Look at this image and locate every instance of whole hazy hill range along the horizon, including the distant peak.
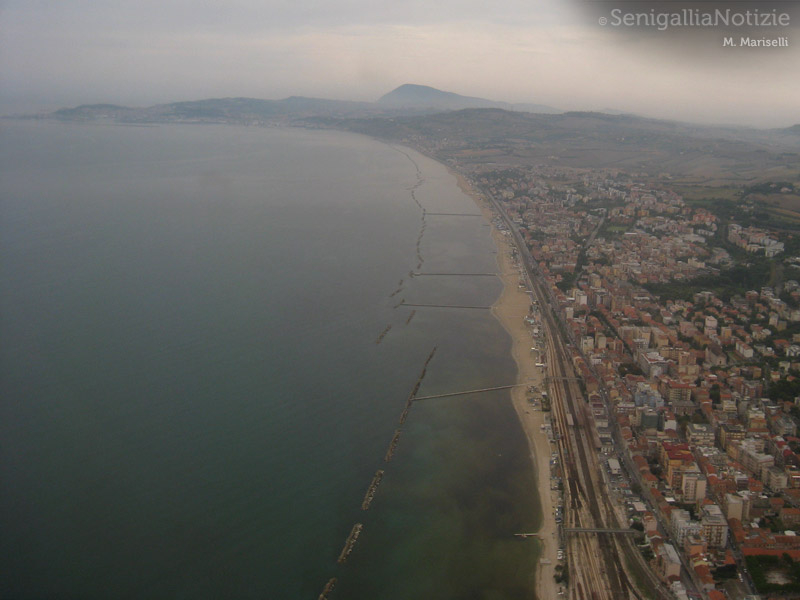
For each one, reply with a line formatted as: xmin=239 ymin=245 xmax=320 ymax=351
xmin=26 ymin=84 xmax=800 ymax=185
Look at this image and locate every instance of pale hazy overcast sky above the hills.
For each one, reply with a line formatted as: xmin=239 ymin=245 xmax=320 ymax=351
xmin=0 ymin=0 xmax=800 ymax=127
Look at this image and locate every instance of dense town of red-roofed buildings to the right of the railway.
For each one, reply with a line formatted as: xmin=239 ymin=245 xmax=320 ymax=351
xmin=468 ymin=166 xmax=800 ymax=599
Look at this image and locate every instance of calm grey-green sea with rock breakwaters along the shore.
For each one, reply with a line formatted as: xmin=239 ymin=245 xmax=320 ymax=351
xmin=0 ymin=120 xmax=542 ymax=600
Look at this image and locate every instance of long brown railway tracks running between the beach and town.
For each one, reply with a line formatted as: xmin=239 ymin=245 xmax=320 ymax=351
xmin=496 ymin=198 xmax=672 ymax=600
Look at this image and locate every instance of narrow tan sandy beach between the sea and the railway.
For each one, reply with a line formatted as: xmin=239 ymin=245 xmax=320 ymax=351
xmin=456 ymin=174 xmax=558 ymax=600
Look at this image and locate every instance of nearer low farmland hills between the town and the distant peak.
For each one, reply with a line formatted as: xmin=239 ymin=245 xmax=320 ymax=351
xmin=337 ymin=108 xmax=800 ymax=184
